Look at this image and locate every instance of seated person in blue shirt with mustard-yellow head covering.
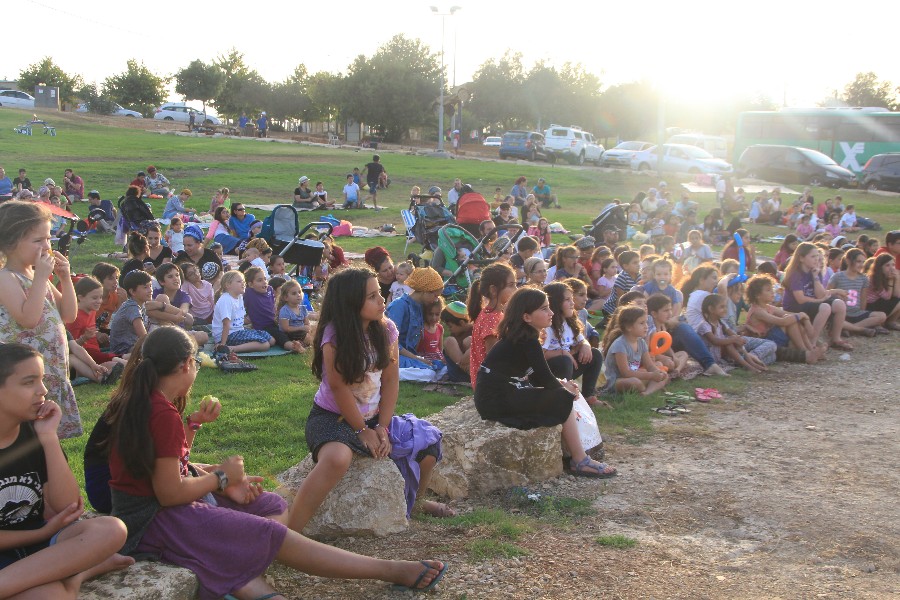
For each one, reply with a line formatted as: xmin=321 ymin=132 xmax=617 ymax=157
xmin=386 ymin=267 xmax=444 ymax=369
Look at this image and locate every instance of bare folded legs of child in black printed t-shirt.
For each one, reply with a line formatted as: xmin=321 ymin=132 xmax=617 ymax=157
xmin=0 ymin=517 xmax=134 ymax=600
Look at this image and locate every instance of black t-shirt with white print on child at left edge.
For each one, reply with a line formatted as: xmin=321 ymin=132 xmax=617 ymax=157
xmin=0 ymin=422 xmax=47 ymax=531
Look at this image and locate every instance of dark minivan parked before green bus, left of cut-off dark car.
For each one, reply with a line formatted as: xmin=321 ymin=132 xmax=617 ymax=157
xmin=737 ymin=144 xmax=857 ymax=188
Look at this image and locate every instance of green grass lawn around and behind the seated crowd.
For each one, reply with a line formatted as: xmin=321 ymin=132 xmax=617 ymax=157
xmin=0 ymin=109 xmax=900 ymax=506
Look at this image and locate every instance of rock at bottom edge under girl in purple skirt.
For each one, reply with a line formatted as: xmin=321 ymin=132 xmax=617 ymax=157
xmin=78 ymin=561 xmax=198 ymax=600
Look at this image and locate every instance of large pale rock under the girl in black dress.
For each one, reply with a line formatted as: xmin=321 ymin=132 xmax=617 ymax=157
xmin=428 ymin=397 xmax=562 ymax=498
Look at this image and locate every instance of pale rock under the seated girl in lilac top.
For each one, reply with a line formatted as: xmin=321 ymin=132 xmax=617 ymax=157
xmin=275 ymin=454 xmax=408 ymax=538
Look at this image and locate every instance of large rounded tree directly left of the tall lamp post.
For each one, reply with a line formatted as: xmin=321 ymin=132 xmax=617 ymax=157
xmin=341 ymin=35 xmax=440 ymax=141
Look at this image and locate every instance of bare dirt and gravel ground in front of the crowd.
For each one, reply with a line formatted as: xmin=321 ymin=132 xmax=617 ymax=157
xmin=272 ymin=335 xmax=900 ymax=600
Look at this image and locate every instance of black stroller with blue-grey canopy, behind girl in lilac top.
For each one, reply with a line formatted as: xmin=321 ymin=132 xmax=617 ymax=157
xmin=259 ymin=204 xmax=334 ymax=287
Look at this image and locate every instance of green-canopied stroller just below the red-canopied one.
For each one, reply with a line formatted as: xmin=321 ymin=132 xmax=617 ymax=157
xmin=438 ymin=224 xmax=522 ymax=300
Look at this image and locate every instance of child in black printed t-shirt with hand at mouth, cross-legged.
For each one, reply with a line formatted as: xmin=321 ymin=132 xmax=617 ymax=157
xmin=0 ymin=344 xmax=134 ymax=598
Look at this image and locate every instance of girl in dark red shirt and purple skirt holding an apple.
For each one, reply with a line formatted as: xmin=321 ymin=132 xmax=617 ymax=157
xmin=106 ymin=327 xmax=446 ymax=600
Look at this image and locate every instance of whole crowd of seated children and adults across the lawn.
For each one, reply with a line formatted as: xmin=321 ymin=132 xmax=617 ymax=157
xmin=0 ymin=157 xmax=900 ymax=595
